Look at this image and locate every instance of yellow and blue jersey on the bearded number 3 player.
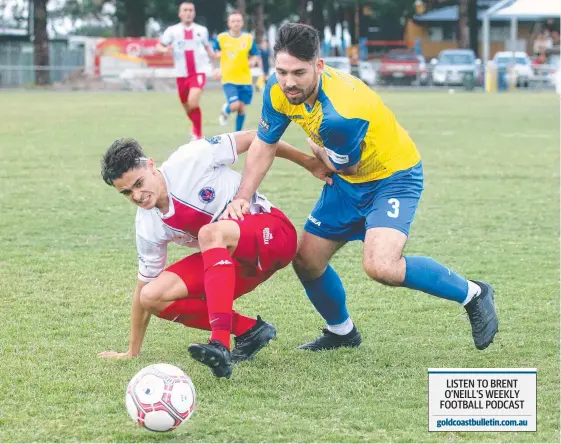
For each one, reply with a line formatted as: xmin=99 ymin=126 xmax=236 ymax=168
xmin=258 ymin=66 xmax=421 ymax=183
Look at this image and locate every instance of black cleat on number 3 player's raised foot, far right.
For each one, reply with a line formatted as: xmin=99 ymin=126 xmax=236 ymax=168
xmin=464 ymin=281 xmax=499 ymax=350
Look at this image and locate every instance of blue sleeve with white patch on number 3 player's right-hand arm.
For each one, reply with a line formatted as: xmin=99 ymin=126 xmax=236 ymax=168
xmin=319 ymin=116 xmax=369 ymax=169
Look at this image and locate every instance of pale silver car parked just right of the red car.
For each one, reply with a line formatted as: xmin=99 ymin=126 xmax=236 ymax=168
xmin=431 ymin=49 xmax=481 ymax=86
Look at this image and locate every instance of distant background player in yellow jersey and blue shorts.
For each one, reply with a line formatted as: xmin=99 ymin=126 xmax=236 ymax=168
xmin=214 ymin=11 xmax=259 ymax=131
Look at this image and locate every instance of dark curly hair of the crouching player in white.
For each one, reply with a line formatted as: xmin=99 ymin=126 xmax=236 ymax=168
xmin=101 ymin=139 xmax=146 ymax=186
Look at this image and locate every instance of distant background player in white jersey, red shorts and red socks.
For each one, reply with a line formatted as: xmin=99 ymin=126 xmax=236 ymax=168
xmin=156 ymin=2 xmax=215 ymax=140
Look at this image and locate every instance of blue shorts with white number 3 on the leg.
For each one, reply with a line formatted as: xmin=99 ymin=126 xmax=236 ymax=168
xmin=304 ymin=162 xmax=423 ymax=241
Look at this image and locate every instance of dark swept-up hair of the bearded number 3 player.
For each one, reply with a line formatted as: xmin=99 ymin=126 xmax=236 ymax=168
xmin=273 ymin=23 xmax=320 ymax=62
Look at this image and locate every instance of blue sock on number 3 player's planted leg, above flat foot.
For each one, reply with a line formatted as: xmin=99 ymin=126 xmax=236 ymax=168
xmin=300 ymin=265 xmax=349 ymax=325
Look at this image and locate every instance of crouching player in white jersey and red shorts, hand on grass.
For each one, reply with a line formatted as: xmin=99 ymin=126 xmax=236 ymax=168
xmin=100 ymin=131 xmax=331 ymax=377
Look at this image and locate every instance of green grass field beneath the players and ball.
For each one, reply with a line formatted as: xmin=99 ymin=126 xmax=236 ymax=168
xmin=0 ymin=91 xmax=560 ymax=442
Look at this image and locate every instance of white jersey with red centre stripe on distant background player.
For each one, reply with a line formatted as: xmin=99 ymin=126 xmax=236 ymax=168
xmin=160 ymin=23 xmax=210 ymax=77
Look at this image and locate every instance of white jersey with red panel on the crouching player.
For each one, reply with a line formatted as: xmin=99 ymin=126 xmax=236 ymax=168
xmin=136 ymin=134 xmax=272 ymax=282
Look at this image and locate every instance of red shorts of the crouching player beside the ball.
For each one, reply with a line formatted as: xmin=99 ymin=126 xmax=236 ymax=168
xmin=166 ymin=208 xmax=298 ymax=298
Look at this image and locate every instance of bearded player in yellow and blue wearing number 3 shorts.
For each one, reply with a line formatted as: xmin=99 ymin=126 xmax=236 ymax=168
xmin=222 ymin=23 xmax=498 ymax=351
